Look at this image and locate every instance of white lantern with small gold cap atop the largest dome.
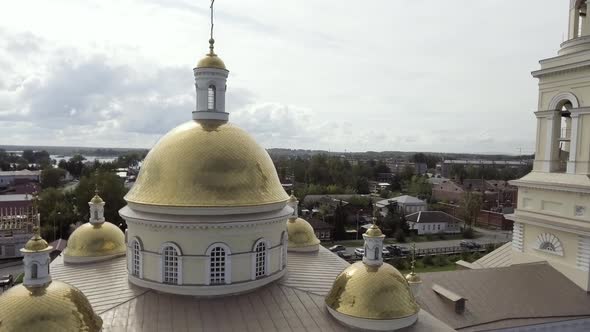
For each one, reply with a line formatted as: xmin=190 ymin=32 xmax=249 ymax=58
xmin=193 ymin=37 xmax=229 ymax=121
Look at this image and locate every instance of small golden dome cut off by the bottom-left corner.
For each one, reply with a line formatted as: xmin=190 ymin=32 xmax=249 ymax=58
xmin=0 ymin=281 xmax=102 ymax=332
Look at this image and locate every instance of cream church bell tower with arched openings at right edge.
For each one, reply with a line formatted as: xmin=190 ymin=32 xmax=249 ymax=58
xmin=511 ymin=0 xmax=590 ymax=291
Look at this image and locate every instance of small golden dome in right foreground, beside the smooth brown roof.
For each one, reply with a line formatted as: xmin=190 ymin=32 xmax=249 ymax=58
xmin=326 ymin=262 xmax=420 ymax=320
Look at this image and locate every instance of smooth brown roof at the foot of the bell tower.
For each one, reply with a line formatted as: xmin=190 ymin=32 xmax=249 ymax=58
xmin=418 ymin=263 xmax=590 ymax=331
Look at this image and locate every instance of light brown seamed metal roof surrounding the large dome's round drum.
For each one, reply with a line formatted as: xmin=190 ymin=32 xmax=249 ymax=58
xmin=51 ymin=247 xmax=453 ymax=331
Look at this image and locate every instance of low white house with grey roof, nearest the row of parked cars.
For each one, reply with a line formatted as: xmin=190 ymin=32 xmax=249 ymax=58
xmin=406 ymin=211 xmax=463 ymax=235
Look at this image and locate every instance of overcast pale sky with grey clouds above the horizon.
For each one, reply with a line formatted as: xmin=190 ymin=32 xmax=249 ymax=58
xmin=0 ymin=0 xmax=569 ymax=153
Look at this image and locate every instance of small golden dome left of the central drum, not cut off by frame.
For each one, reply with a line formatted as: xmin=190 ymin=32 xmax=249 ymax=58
xmin=64 ymin=222 xmax=126 ymax=260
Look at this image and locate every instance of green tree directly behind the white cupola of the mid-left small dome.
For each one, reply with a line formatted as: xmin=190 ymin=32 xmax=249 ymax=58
xmin=74 ymin=171 xmax=127 ymax=225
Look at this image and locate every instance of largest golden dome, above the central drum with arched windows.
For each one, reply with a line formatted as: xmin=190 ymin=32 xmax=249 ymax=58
xmin=125 ymin=120 xmax=289 ymax=207
